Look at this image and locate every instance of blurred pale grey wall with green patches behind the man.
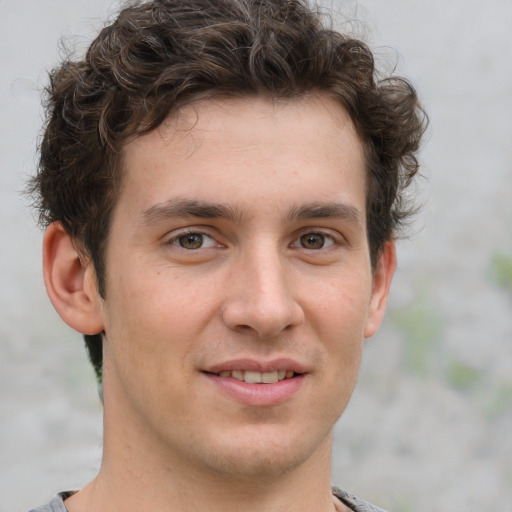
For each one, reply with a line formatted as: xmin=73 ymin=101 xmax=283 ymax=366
xmin=0 ymin=0 xmax=512 ymax=512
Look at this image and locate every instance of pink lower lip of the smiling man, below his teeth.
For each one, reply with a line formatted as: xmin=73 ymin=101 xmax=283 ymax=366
xmin=204 ymin=373 xmax=306 ymax=407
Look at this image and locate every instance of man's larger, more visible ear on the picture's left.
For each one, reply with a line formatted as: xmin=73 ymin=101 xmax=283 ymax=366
xmin=43 ymin=222 xmax=103 ymax=334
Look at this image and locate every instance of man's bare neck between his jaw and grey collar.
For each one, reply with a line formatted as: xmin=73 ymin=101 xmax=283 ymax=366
xmin=66 ymin=424 xmax=335 ymax=512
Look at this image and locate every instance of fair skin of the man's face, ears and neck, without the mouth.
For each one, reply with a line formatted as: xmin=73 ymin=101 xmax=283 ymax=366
xmin=44 ymin=95 xmax=395 ymax=512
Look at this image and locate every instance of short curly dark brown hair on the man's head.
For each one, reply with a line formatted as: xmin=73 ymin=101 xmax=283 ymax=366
xmin=29 ymin=0 xmax=427 ymax=380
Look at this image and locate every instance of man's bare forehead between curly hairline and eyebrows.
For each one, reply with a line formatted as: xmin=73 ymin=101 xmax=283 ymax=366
xmin=118 ymin=94 xmax=365 ymax=221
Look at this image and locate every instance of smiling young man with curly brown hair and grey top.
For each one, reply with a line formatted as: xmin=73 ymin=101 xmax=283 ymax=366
xmin=32 ymin=0 xmax=424 ymax=512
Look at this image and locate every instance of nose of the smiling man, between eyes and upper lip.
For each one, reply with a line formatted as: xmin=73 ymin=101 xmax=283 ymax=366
xmin=222 ymin=248 xmax=304 ymax=339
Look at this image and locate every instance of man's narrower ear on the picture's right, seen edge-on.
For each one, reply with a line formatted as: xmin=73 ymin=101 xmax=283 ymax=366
xmin=364 ymin=240 xmax=396 ymax=338
